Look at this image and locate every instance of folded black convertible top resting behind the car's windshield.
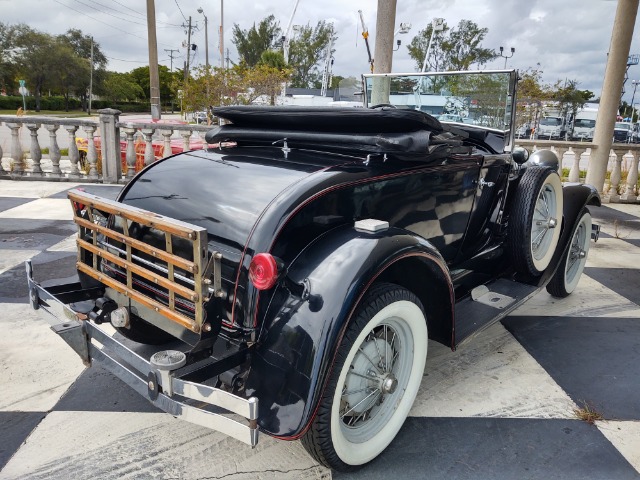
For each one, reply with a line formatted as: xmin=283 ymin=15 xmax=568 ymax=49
xmin=205 ymin=105 xmax=467 ymax=159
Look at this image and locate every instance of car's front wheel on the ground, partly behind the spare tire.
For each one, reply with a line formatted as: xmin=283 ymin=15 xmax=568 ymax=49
xmin=547 ymin=208 xmax=591 ymax=298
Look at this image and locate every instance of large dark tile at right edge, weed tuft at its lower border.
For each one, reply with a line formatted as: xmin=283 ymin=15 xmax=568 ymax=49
xmin=502 ymin=317 xmax=640 ymax=420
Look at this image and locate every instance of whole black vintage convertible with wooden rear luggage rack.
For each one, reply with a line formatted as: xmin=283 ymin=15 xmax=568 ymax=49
xmin=27 ymin=71 xmax=600 ymax=470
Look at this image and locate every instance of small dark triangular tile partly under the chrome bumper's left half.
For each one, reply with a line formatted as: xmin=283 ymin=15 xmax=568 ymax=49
xmin=53 ymin=360 xmax=161 ymax=412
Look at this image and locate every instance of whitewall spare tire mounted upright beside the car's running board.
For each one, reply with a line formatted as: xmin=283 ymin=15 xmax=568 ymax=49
xmin=507 ymin=166 xmax=563 ymax=275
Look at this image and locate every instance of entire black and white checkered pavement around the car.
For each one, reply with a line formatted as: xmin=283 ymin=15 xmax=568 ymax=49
xmin=0 ymin=180 xmax=640 ymax=480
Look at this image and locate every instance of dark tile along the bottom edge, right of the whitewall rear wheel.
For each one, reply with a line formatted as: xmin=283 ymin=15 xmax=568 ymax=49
xmin=333 ymin=417 xmax=640 ymax=480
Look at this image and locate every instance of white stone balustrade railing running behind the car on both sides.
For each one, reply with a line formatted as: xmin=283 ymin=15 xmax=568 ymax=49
xmin=0 ymin=115 xmax=640 ymax=203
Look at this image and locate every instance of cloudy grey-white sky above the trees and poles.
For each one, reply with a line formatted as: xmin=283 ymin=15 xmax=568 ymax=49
xmin=0 ymin=0 xmax=640 ymax=101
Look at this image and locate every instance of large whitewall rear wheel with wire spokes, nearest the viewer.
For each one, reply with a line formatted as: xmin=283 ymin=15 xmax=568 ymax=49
xmin=302 ymin=284 xmax=428 ymax=471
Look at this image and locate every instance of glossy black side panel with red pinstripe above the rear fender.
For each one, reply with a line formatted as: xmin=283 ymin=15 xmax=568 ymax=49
xmin=240 ymin=156 xmax=480 ymax=327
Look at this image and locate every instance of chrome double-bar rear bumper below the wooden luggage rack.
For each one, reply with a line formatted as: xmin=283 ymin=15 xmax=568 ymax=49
xmin=26 ymin=261 xmax=258 ymax=447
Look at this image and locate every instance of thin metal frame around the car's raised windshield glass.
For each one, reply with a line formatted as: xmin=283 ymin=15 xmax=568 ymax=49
xmin=362 ymin=70 xmax=518 ymax=152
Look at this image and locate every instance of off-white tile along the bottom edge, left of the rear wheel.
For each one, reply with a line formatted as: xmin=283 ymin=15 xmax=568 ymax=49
xmin=0 ymin=412 xmax=330 ymax=480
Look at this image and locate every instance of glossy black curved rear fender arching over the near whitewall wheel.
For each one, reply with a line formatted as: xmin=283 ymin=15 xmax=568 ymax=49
xmin=242 ymin=226 xmax=454 ymax=439
